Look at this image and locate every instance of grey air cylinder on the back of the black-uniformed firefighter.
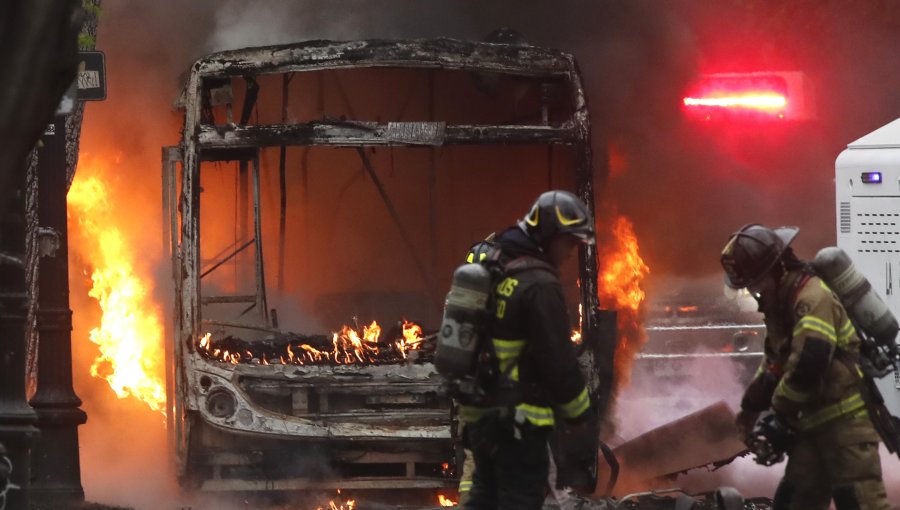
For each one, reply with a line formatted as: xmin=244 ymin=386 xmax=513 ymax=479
xmin=434 ymin=264 xmax=491 ymax=379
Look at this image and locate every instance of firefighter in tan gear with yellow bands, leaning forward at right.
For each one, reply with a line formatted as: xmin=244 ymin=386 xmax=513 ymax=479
xmin=721 ymin=225 xmax=889 ymax=510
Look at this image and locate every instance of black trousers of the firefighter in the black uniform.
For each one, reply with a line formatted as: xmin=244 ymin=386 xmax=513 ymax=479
xmin=462 ymin=418 xmax=549 ymax=510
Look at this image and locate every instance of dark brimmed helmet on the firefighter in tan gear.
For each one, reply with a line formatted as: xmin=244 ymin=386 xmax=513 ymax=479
xmin=721 ymin=224 xmax=800 ymax=289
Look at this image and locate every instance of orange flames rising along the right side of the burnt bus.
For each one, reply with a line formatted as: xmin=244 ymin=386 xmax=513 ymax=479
xmin=598 ymin=216 xmax=650 ymax=388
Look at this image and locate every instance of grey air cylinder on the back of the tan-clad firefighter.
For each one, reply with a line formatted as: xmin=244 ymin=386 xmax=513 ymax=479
xmin=813 ymin=246 xmax=900 ymax=375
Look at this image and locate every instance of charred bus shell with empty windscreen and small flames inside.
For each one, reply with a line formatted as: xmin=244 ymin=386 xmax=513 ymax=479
xmin=162 ymin=39 xmax=765 ymax=508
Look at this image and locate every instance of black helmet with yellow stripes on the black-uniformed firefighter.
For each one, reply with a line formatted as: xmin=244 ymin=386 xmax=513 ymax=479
xmin=519 ymin=190 xmax=594 ymax=248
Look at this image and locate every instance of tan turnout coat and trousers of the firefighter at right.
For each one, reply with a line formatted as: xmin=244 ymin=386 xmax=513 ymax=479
xmin=741 ymin=270 xmax=888 ymax=510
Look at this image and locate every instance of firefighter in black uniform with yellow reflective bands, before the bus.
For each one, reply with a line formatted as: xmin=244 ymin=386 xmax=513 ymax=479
xmin=459 ymin=191 xmax=597 ymax=510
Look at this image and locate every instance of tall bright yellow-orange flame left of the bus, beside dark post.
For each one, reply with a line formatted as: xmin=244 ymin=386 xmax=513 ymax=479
xmin=68 ymin=157 xmax=166 ymax=414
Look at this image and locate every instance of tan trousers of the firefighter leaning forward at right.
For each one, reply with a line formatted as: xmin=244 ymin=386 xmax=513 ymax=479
xmin=774 ymin=417 xmax=890 ymax=510
